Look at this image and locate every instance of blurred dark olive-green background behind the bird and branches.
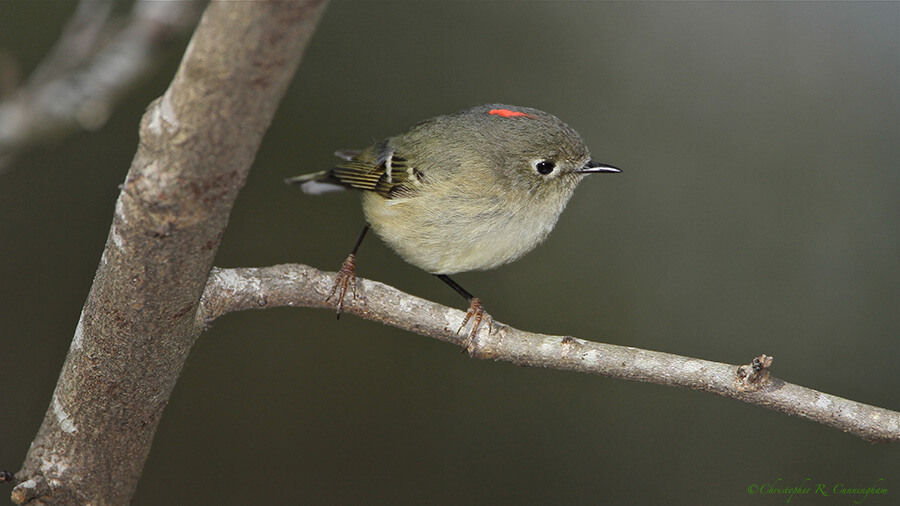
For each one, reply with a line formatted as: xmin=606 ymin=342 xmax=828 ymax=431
xmin=0 ymin=1 xmax=900 ymax=505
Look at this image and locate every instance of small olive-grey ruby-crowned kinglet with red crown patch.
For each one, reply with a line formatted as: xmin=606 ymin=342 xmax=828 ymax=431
xmin=285 ymin=104 xmax=620 ymax=338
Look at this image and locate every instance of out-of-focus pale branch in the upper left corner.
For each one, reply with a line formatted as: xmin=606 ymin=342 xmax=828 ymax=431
xmin=0 ymin=0 xmax=200 ymax=170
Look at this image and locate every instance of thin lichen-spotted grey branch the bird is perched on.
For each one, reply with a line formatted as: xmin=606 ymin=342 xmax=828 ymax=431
xmin=197 ymin=264 xmax=900 ymax=443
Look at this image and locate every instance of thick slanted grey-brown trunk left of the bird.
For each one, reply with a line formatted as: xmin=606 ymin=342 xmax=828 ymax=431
xmin=13 ymin=0 xmax=324 ymax=504
